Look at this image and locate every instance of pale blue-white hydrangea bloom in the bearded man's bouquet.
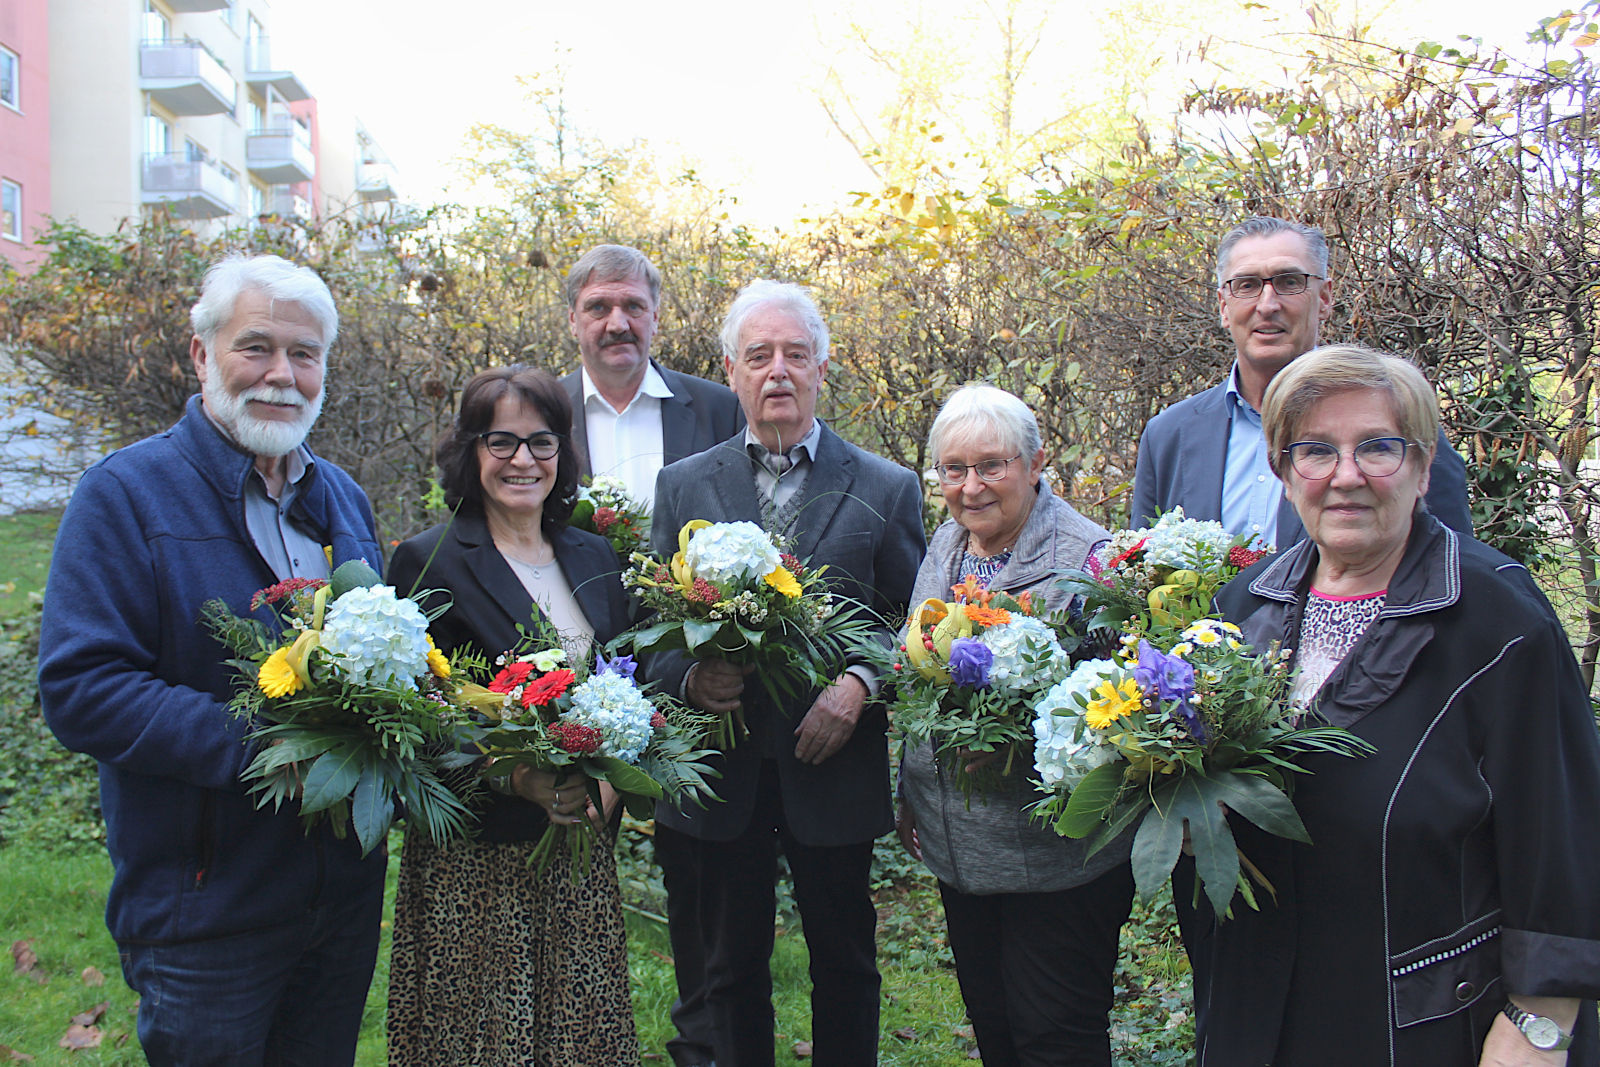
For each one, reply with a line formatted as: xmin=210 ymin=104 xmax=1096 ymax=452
xmin=322 ymin=585 xmax=429 ymax=689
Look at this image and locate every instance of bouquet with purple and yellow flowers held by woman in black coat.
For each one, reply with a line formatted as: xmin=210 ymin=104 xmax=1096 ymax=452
xmin=1034 ymin=619 xmax=1373 ymax=917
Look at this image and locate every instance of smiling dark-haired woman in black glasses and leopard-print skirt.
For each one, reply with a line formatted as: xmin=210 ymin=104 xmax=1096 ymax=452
xmin=389 ymin=365 xmax=638 ymax=1067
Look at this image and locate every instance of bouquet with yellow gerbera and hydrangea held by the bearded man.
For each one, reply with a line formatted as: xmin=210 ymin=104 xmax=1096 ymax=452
xmin=203 ymin=560 xmax=472 ymax=856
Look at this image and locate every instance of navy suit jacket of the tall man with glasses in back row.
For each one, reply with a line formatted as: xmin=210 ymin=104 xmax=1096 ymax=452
xmin=1128 ymin=382 xmax=1472 ymax=550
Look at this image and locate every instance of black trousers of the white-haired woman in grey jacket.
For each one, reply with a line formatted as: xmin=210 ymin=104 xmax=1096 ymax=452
xmin=939 ymin=864 xmax=1133 ymax=1067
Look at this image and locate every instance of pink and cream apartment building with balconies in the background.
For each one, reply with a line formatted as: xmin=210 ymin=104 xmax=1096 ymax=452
xmin=0 ymin=0 xmax=395 ymax=271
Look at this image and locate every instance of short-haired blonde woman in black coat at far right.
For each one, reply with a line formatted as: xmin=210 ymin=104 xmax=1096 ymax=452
xmin=1197 ymin=346 xmax=1600 ymax=1067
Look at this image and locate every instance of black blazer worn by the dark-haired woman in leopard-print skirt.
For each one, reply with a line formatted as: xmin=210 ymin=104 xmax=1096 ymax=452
xmin=387 ymin=509 xmax=632 ymax=841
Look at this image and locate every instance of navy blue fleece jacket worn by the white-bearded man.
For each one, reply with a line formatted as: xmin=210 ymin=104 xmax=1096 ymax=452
xmin=38 ymin=397 xmax=384 ymax=942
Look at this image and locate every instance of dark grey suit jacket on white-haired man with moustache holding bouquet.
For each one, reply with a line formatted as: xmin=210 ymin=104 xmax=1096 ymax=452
xmin=648 ymin=427 xmax=926 ymax=846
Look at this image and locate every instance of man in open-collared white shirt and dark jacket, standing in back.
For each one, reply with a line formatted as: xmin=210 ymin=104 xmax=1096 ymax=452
xmin=562 ymin=245 xmax=744 ymax=509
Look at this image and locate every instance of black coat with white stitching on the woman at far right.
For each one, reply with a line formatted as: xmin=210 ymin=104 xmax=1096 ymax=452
xmin=1186 ymin=515 xmax=1600 ymax=1067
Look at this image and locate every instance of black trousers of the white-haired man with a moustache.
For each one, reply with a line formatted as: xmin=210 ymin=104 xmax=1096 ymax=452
xmin=693 ymin=760 xmax=882 ymax=1067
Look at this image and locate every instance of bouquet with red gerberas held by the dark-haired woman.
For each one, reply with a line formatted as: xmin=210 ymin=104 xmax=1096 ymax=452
xmin=466 ymin=643 xmax=717 ymax=881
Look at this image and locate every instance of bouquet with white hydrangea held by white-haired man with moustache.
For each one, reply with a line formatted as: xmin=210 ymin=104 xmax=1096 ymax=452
xmin=614 ymin=518 xmax=872 ymax=749
